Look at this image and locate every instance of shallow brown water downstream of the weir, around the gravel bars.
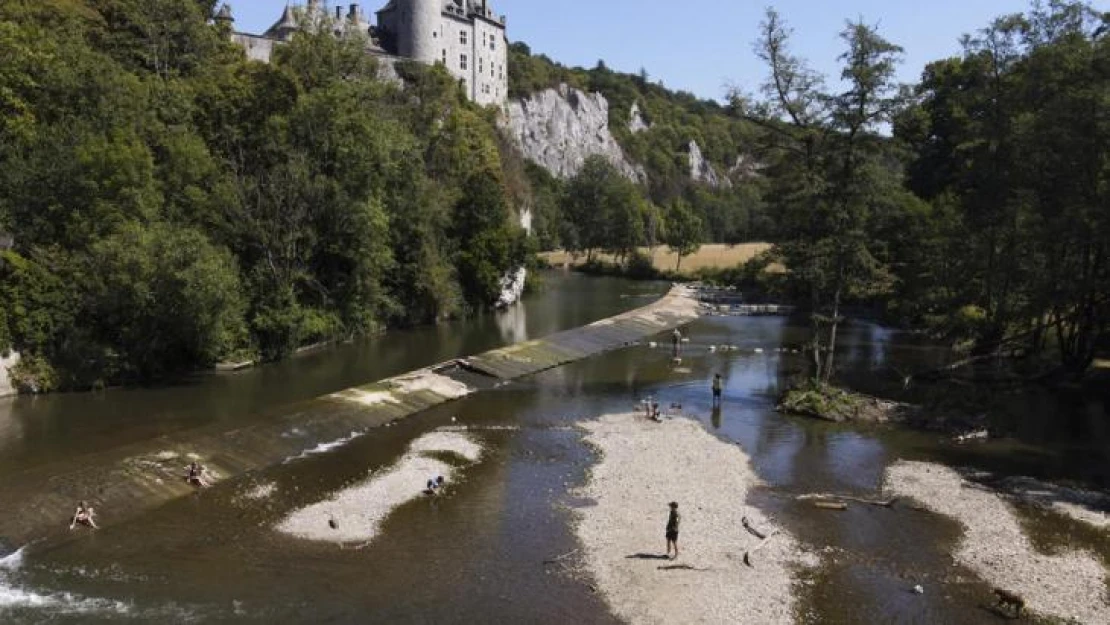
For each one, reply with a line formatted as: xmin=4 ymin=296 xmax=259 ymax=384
xmin=0 ymin=295 xmax=1110 ymax=624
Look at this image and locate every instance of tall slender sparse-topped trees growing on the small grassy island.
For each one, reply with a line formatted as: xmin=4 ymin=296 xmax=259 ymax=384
xmin=733 ymin=9 xmax=902 ymax=384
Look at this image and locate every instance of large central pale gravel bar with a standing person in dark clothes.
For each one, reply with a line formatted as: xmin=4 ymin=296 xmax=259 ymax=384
xmin=577 ymin=414 xmax=816 ymax=624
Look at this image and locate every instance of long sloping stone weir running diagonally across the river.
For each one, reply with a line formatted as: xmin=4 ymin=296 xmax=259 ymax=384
xmin=0 ymin=286 xmax=698 ymax=545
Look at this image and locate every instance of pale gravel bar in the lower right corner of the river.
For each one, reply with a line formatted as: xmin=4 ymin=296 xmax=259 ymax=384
xmin=886 ymin=462 xmax=1110 ymax=623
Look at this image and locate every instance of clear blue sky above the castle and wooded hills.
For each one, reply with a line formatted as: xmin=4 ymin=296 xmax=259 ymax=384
xmin=230 ymin=0 xmax=1047 ymax=99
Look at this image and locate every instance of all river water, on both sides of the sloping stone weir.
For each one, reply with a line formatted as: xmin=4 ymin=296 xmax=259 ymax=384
xmin=0 ymin=274 xmax=1110 ymax=624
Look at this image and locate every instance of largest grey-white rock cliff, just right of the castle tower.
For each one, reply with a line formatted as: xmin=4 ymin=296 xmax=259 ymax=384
xmin=506 ymin=84 xmax=646 ymax=181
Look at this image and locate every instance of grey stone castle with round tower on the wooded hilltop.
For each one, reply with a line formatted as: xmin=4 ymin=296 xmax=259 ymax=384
xmin=224 ymin=0 xmax=508 ymax=105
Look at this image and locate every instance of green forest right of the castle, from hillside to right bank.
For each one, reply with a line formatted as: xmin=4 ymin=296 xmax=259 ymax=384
xmin=511 ymin=0 xmax=1110 ymax=382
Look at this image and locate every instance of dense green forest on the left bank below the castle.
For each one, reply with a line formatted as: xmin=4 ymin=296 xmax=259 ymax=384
xmin=0 ymin=0 xmax=528 ymax=391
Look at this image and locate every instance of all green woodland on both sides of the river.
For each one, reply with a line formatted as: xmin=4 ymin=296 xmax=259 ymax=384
xmin=0 ymin=0 xmax=1110 ymax=391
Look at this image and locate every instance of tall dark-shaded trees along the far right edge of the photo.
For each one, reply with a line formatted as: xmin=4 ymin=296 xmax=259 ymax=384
xmin=895 ymin=0 xmax=1110 ymax=373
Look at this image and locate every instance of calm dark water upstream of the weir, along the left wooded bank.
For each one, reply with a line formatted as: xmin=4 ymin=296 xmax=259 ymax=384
xmin=0 ymin=272 xmax=667 ymax=471
